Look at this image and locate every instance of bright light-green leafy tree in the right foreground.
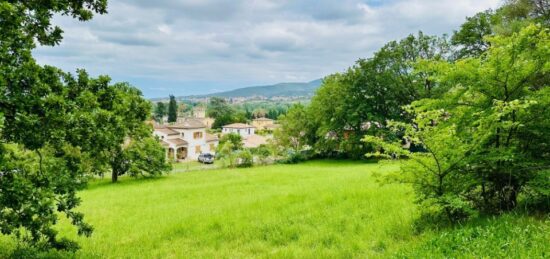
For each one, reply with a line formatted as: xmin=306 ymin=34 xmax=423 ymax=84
xmin=365 ymin=25 xmax=550 ymax=222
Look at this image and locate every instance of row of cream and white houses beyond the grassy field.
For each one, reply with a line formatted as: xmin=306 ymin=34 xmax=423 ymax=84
xmin=153 ymin=118 xmax=276 ymax=161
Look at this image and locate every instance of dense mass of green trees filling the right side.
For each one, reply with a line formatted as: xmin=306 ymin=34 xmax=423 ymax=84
xmin=275 ymin=0 xmax=550 ymax=224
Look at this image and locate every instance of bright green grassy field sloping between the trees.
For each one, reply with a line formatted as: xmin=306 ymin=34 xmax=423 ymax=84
xmin=0 ymin=161 xmax=550 ymax=258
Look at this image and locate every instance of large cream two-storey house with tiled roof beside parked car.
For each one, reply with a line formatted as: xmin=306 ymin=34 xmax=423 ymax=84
xmin=153 ymin=119 xmax=218 ymax=161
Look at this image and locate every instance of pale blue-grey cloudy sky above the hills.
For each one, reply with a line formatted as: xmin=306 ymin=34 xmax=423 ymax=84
xmin=35 ymin=0 xmax=501 ymax=97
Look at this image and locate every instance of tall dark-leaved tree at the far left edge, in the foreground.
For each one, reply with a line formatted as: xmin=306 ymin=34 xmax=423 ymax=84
xmin=0 ymin=0 xmax=107 ymax=252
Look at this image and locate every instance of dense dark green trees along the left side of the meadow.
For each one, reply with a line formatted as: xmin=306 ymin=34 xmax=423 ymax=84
xmin=0 ymin=0 xmax=169 ymax=253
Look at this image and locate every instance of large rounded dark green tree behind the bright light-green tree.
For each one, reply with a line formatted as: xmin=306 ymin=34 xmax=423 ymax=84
xmin=309 ymin=32 xmax=451 ymax=159
